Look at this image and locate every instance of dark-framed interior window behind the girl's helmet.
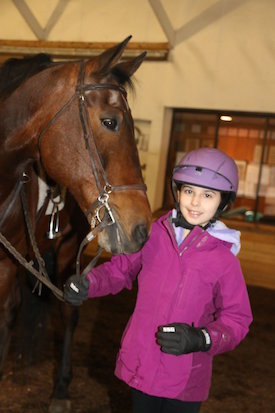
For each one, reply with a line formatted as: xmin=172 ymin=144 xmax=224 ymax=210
xmin=163 ymin=109 xmax=275 ymax=225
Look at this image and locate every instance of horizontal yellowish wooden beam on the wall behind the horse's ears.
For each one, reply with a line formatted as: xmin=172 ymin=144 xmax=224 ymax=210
xmin=0 ymin=40 xmax=169 ymax=61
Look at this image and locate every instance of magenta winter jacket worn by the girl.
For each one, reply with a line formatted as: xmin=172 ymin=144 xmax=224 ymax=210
xmin=87 ymin=213 xmax=252 ymax=401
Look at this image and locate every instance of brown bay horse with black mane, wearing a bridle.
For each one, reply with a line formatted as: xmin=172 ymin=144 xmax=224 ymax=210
xmin=0 ymin=36 xmax=152 ymax=413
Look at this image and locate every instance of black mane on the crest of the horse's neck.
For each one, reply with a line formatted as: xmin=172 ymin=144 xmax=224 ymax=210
xmin=0 ymin=53 xmax=52 ymax=98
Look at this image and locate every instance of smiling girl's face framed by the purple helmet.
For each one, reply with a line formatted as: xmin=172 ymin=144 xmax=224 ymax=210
xmin=178 ymin=184 xmax=221 ymax=226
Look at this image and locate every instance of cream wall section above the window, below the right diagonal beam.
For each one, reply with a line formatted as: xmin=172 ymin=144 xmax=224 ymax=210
xmin=129 ymin=0 xmax=275 ymax=210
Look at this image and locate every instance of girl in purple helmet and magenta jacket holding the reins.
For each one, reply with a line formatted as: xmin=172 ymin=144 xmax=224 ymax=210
xmin=64 ymin=148 xmax=252 ymax=413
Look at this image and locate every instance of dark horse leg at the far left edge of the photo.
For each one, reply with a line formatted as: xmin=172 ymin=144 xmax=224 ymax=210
xmin=0 ymin=259 xmax=21 ymax=377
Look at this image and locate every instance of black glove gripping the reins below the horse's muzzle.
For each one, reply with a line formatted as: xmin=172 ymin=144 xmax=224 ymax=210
xmin=64 ymin=275 xmax=90 ymax=305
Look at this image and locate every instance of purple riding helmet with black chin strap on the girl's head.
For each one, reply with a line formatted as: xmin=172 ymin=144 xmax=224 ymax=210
xmin=172 ymin=148 xmax=239 ymax=229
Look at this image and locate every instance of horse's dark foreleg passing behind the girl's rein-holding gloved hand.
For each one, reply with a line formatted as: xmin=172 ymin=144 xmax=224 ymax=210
xmin=49 ymin=194 xmax=89 ymax=413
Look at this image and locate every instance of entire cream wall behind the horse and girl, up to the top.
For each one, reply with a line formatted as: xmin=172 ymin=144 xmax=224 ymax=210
xmin=0 ymin=0 xmax=275 ymax=210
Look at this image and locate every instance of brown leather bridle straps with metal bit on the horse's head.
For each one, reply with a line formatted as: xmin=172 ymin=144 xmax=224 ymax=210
xmin=38 ymin=61 xmax=149 ymax=233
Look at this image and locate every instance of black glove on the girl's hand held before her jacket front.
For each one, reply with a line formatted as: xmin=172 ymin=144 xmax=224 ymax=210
xmin=157 ymin=323 xmax=211 ymax=356
